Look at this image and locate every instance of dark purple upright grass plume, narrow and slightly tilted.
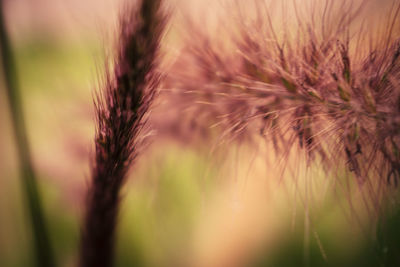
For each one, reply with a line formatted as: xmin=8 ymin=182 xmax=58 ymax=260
xmin=79 ymin=0 xmax=166 ymax=267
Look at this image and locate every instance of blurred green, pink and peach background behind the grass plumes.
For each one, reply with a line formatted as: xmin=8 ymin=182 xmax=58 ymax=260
xmin=0 ymin=0 xmax=400 ymax=267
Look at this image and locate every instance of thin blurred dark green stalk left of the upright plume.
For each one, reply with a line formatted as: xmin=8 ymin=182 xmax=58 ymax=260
xmin=0 ymin=0 xmax=55 ymax=267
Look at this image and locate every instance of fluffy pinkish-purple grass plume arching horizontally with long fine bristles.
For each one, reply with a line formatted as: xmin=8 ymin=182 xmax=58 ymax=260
xmin=165 ymin=0 xmax=400 ymax=194
